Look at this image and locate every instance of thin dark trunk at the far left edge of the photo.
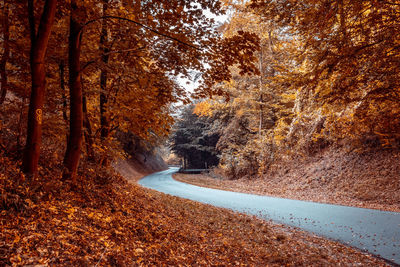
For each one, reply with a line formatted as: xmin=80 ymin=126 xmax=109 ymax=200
xmin=0 ymin=1 xmax=10 ymax=105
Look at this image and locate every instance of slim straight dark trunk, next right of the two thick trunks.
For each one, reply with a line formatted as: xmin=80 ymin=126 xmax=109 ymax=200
xmin=100 ymin=0 xmax=110 ymax=166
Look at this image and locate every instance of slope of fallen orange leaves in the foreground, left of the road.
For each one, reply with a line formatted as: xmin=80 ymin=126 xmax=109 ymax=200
xmin=0 ymin=151 xmax=387 ymax=266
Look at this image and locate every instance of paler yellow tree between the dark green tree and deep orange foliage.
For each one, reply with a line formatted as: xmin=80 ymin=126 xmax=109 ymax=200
xmin=198 ymin=1 xmax=297 ymax=178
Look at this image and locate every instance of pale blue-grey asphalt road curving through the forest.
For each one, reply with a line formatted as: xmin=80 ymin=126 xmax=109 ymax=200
xmin=139 ymin=168 xmax=400 ymax=264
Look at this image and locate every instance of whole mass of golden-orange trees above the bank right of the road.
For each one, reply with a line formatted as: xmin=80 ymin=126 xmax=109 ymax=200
xmin=190 ymin=0 xmax=400 ymax=180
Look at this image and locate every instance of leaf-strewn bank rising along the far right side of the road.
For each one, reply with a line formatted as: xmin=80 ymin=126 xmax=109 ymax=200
xmin=173 ymin=150 xmax=400 ymax=212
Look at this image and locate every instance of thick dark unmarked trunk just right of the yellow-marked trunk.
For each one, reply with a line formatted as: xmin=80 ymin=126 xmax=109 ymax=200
xmin=63 ymin=0 xmax=83 ymax=184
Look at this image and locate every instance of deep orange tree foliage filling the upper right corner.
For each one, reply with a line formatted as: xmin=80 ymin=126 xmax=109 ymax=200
xmin=251 ymin=0 xmax=400 ymax=147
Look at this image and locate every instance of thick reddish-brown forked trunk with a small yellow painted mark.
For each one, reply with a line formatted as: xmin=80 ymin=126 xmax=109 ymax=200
xmin=23 ymin=0 xmax=57 ymax=175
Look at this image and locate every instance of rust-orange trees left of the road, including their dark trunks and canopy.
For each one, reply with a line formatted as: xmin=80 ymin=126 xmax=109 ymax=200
xmin=0 ymin=0 xmax=257 ymax=179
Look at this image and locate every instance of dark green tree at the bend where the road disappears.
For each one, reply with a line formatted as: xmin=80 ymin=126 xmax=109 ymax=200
xmin=171 ymin=105 xmax=219 ymax=169
